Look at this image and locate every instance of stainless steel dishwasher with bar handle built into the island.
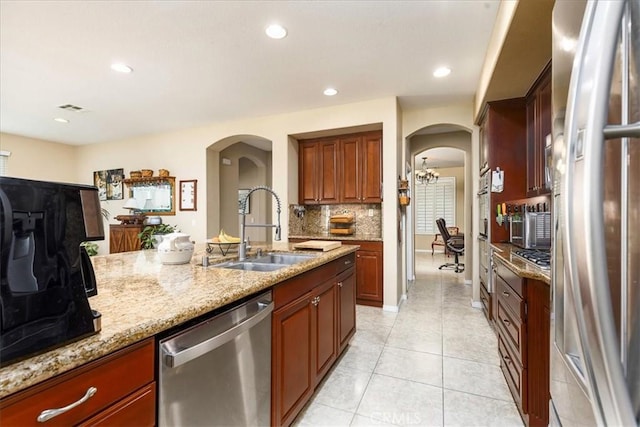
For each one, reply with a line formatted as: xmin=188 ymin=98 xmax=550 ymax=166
xmin=158 ymin=291 xmax=273 ymax=426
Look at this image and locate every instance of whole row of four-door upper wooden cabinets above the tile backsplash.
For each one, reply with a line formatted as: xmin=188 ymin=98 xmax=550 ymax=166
xmin=298 ymin=131 xmax=382 ymax=205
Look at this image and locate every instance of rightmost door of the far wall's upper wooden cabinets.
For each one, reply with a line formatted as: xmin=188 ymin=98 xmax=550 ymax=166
xmin=359 ymin=132 xmax=382 ymax=203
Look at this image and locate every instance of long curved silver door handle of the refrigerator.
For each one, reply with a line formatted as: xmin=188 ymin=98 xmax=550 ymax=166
xmin=562 ymin=1 xmax=637 ymax=425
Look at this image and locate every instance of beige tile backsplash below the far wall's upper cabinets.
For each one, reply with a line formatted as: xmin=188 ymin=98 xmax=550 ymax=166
xmin=289 ymin=204 xmax=382 ymax=237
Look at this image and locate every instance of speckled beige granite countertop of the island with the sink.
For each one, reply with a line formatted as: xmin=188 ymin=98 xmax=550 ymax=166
xmin=0 ymin=242 xmax=358 ymax=398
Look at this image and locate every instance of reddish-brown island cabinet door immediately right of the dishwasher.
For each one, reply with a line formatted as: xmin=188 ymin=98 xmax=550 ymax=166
xmin=271 ymin=292 xmax=316 ymax=425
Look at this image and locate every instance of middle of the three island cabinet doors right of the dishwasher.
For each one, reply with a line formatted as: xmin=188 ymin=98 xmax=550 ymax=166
xmin=311 ymin=278 xmax=338 ymax=384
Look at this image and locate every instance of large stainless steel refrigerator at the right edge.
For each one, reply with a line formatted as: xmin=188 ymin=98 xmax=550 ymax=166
xmin=550 ymin=0 xmax=640 ymax=427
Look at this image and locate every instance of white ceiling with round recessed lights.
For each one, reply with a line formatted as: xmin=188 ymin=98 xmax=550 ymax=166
xmin=0 ymin=0 xmax=499 ymax=145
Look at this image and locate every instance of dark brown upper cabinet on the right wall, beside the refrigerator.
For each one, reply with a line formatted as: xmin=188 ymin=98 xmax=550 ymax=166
xmin=526 ymin=63 xmax=551 ymax=197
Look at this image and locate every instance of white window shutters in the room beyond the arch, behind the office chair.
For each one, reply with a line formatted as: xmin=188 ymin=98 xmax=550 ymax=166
xmin=414 ymin=176 xmax=456 ymax=234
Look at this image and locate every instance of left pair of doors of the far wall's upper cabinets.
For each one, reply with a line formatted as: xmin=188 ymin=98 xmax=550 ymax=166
xmin=298 ymin=138 xmax=339 ymax=205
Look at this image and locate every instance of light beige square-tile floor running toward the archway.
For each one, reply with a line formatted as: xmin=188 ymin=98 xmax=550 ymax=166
xmin=295 ymin=253 xmax=522 ymax=426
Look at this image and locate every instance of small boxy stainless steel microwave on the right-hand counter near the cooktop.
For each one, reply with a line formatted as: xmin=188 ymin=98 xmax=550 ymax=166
xmin=509 ymin=210 xmax=551 ymax=249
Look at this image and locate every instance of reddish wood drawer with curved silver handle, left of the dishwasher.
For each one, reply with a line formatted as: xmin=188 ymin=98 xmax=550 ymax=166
xmin=0 ymin=339 xmax=155 ymax=426
